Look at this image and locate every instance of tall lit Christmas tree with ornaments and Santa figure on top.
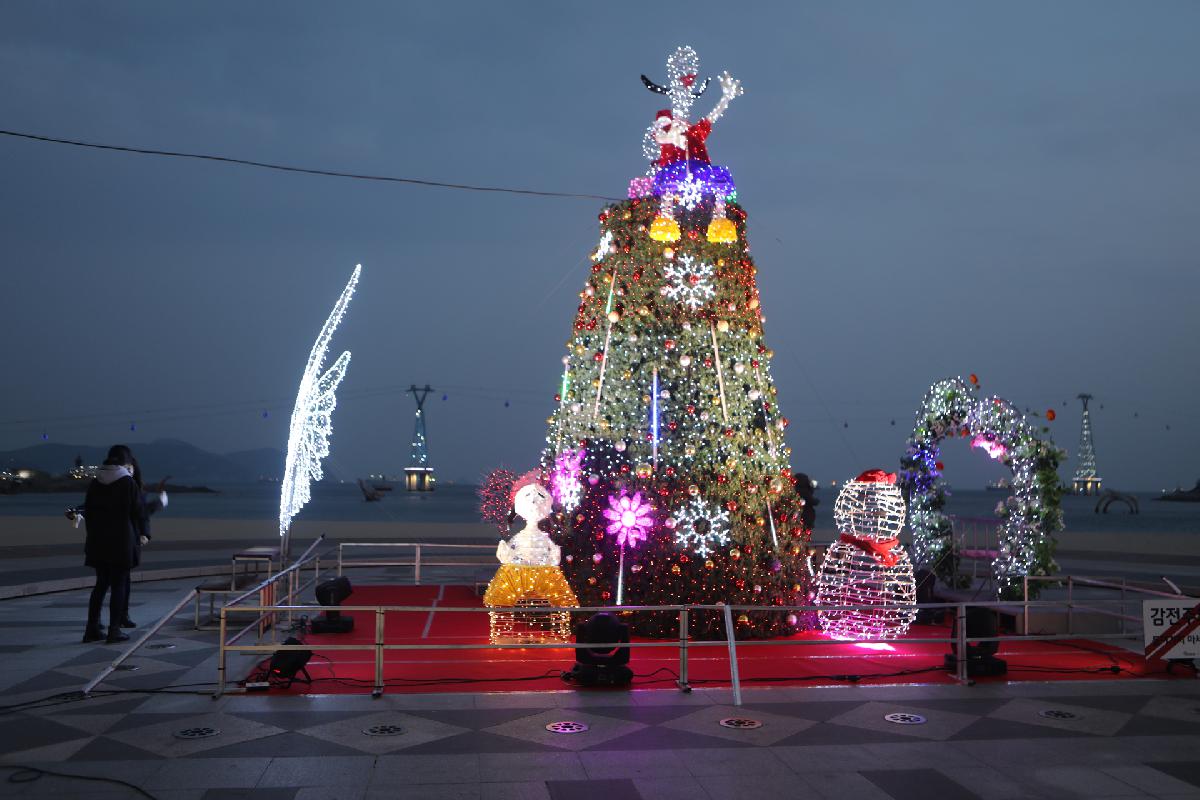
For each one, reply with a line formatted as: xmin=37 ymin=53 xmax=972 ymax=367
xmin=542 ymin=48 xmax=811 ymax=637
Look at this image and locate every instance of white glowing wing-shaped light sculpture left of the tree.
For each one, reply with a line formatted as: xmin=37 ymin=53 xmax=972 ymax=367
xmin=280 ymin=264 xmax=362 ymax=559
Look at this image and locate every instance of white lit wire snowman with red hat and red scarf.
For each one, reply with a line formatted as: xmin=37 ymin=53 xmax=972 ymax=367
xmin=816 ymin=469 xmax=917 ymax=639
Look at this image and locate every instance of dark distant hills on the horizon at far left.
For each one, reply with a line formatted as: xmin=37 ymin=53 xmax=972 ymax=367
xmin=0 ymin=439 xmax=283 ymax=485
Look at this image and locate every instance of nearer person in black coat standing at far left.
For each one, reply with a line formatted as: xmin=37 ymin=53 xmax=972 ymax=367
xmin=83 ymin=445 xmax=148 ymax=643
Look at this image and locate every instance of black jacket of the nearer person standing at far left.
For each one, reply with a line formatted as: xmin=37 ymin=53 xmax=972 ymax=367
xmin=83 ymin=464 xmax=148 ymax=570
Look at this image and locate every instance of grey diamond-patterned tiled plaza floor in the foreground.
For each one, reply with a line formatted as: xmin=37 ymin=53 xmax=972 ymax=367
xmin=0 ymin=582 xmax=1200 ymax=800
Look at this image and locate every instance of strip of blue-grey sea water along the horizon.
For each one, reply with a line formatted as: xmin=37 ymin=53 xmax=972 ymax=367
xmin=0 ymin=482 xmax=1200 ymax=534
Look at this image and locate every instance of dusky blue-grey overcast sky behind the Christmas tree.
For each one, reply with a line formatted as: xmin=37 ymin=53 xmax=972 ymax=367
xmin=0 ymin=0 xmax=1200 ymax=489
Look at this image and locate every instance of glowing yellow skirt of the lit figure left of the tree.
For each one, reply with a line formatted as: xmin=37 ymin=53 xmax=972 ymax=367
xmin=484 ymin=564 xmax=580 ymax=644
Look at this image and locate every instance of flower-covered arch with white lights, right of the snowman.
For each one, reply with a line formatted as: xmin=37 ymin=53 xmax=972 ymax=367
xmin=900 ymin=375 xmax=1066 ymax=599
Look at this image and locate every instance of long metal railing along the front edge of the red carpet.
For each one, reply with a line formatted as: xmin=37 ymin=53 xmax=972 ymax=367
xmin=214 ymin=592 xmax=1152 ymax=705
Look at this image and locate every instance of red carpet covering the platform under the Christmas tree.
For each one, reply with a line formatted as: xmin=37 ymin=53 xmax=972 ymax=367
xmin=255 ymin=585 xmax=1190 ymax=694
